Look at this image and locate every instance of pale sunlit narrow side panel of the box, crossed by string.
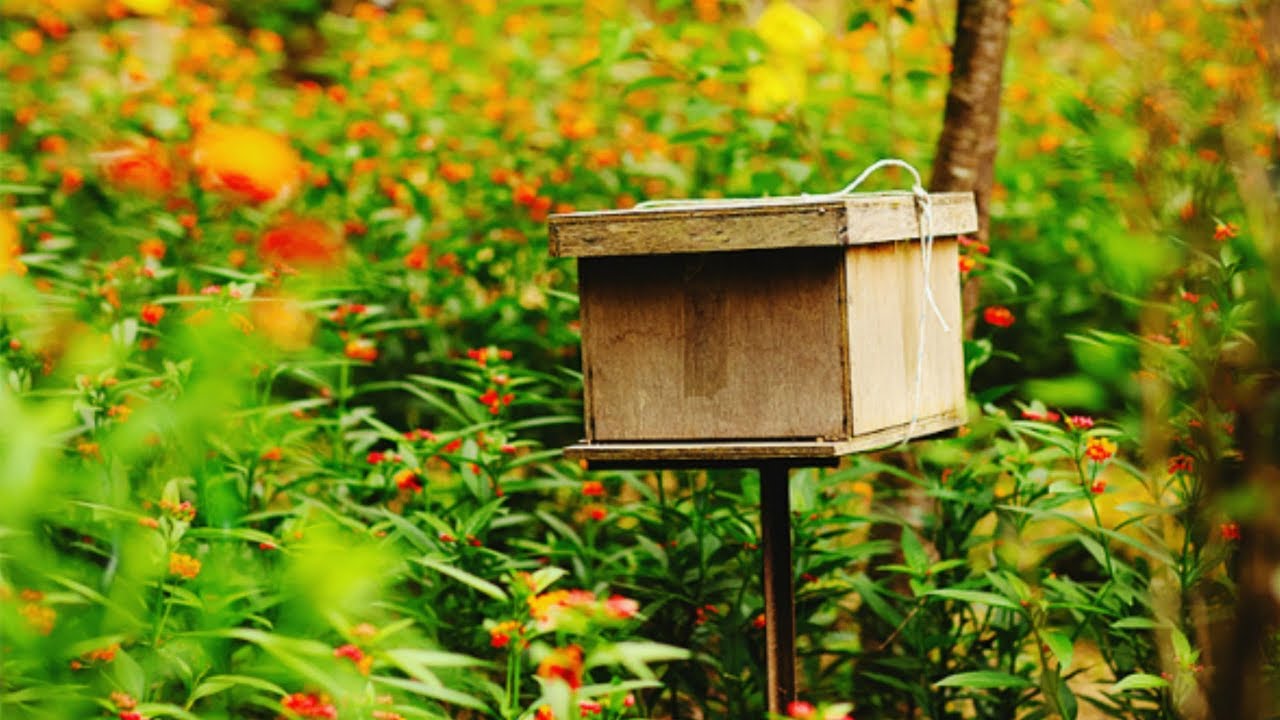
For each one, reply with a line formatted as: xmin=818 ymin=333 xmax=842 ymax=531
xmin=845 ymin=238 xmax=965 ymax=436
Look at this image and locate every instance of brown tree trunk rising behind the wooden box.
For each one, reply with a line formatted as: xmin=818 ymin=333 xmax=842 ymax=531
xmin=929 ymin=0 xmax=1011 ymax=337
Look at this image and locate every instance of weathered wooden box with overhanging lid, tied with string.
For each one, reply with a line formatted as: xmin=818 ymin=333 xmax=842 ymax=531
xmin=550 ymin=192 xmax=978 ymax=457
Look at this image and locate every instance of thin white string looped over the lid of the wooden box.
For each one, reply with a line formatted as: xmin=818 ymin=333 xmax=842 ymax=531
xmin=636 ymin=158 xmax=951 ymax=446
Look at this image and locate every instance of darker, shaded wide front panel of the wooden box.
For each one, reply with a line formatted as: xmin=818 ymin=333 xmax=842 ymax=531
xmin=580 ymin=249 xmax=846 ymax=442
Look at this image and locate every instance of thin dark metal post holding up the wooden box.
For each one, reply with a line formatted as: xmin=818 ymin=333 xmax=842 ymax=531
xmin=760 ymin=464 xmax=796 ymax=715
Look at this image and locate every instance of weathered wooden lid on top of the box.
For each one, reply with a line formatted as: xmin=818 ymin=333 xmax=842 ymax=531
xmin=549 ymin=192 xmax=978 ymax=258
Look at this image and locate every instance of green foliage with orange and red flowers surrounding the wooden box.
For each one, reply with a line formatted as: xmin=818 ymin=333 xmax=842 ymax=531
xmin=0 ymin=0 xmax=1280 ymax=720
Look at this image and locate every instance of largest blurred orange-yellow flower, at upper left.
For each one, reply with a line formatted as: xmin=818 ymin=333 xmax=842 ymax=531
xmin=191 ymin=124 xmax=302 ymax=202
